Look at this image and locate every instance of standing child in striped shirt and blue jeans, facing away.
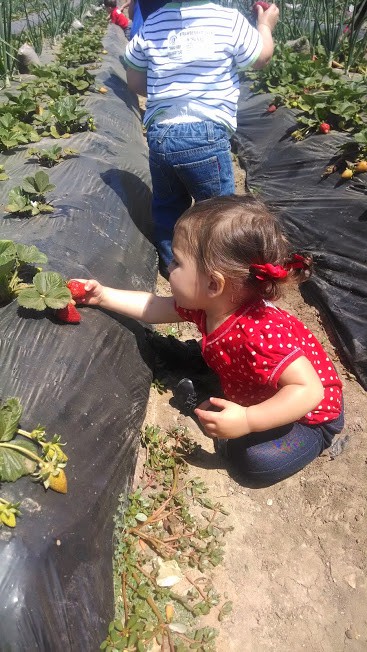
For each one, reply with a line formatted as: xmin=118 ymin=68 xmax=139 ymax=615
xmin=125 ymin=0 xmax=279 ymax=278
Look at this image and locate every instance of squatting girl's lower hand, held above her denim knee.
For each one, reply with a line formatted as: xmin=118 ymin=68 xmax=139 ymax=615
xmin=194 ymin=398 xmax=250 ymax=439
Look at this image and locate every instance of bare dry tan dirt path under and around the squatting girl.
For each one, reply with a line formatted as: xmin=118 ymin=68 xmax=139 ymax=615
xmin=135 ymin=159 xmax=367 ymax=652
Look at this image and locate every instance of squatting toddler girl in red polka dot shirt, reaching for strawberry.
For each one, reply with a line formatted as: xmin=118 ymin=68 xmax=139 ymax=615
xmin=74 ymin=196 xmax=343 ymax=484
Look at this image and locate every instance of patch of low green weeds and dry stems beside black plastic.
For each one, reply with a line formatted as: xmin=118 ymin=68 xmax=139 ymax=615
xmin=101 ymin=426 xmax=232 ymax=652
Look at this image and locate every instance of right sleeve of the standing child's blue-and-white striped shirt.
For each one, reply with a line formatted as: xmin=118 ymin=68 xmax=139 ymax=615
xmin=233 ymin=11 xmax=263 ymax=69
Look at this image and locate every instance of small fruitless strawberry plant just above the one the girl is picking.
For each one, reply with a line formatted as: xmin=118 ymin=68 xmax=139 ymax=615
xmin=5 ymin=170 xmax=56 ymax=216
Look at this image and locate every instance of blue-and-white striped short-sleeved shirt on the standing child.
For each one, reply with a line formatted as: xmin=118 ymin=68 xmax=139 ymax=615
xmin=125 ymin=0 xmax=263 ymax=131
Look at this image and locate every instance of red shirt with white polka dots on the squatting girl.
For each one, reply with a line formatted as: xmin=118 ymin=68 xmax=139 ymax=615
xmin=176 ymin=300 xmax=342 ymax=425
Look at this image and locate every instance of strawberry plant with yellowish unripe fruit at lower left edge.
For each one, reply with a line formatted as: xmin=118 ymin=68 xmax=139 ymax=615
xmin=0 ymin=397 xmax=68 ymax=527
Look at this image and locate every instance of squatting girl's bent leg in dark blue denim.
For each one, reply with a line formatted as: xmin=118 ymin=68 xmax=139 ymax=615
xmin=227 ymin=413 xmax=344 ymax=486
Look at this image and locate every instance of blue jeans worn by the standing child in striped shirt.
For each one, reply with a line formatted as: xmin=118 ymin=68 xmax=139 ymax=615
xmin=147 ymin=120 xmax=235 ymax=273
